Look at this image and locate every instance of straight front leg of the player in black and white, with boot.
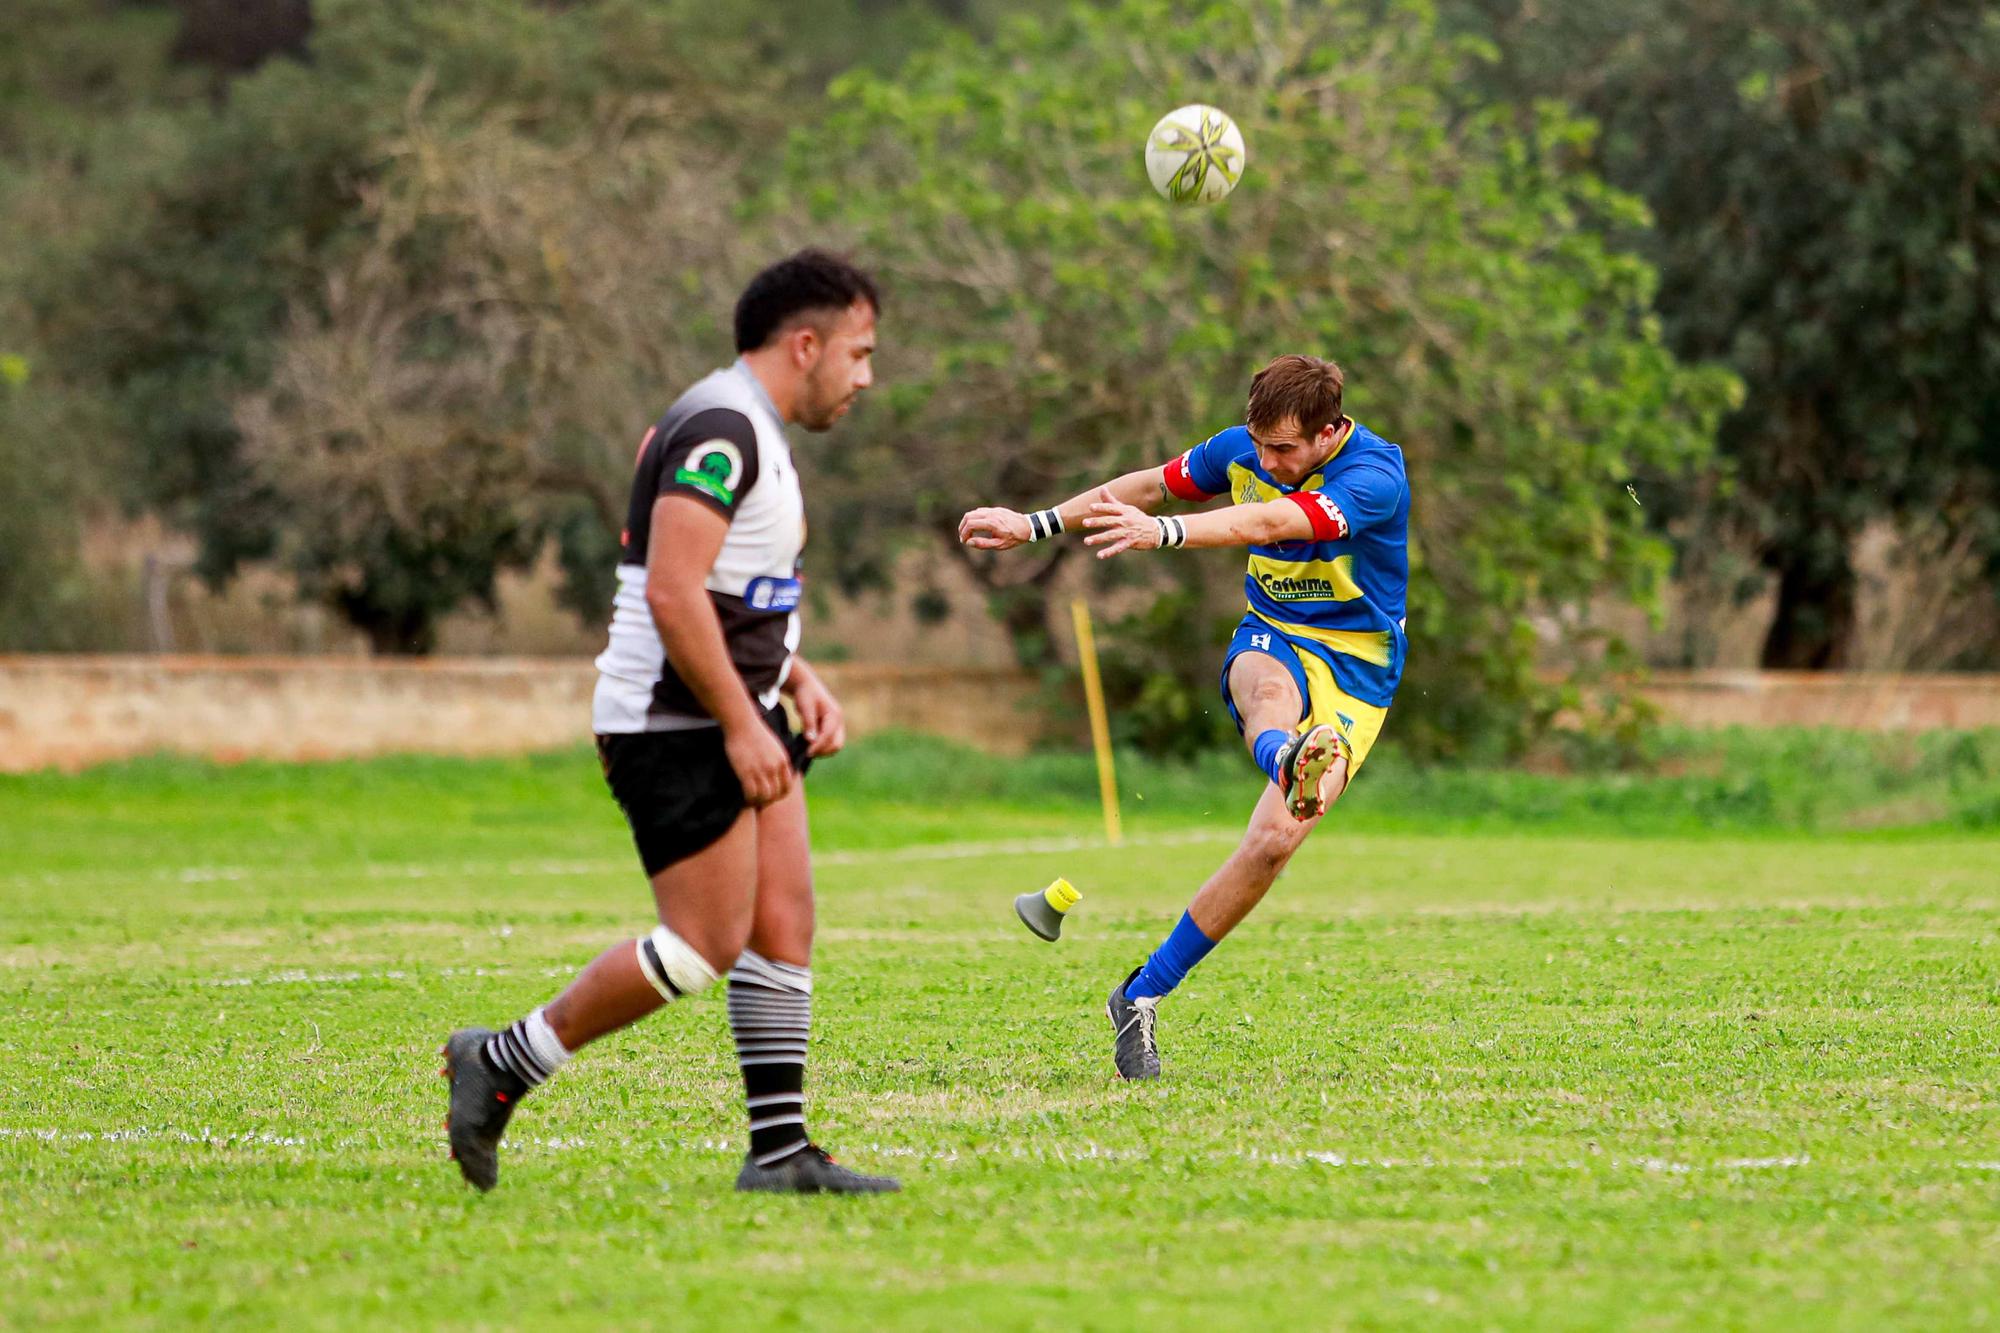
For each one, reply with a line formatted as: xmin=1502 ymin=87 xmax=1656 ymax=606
xmin=730 ymin=787 xmax=900 ymax=1195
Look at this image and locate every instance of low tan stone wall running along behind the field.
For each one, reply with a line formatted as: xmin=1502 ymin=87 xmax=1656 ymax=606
xmin=0 ymin=656 xmax=2000 ymax=773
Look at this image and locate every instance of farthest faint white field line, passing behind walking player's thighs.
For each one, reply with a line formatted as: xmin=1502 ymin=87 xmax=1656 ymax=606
xmin=0 ymin=829 xmax=1240 ymax=889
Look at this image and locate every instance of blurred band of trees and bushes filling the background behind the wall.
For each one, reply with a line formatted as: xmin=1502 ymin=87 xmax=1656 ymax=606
xmin=0 ymin=0 xmax=2000 ymax=753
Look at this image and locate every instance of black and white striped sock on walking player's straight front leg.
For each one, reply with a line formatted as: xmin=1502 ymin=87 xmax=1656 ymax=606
xmin=730 ymin=949 xmax=812 ymax=1167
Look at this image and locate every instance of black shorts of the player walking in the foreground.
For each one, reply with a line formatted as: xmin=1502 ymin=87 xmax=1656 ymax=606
xmin=598 ymin=709 xmax=812 ymax=879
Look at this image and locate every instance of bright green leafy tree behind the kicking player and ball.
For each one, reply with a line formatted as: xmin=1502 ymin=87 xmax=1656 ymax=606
xmin=784 ymin=0 xmax=1732 ymax=753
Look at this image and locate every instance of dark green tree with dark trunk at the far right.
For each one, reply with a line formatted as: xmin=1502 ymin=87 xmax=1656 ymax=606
xmin=1450 ymin=0 xmax=2000 ymax=667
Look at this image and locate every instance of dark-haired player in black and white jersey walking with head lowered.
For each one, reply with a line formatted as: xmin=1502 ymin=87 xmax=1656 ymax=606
xmin=444 ymin=250 xmax=898 ymax=1193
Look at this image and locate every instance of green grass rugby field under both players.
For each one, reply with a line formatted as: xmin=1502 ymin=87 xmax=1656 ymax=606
xmin=0 ymin=739 xmax=2000 ymax=1329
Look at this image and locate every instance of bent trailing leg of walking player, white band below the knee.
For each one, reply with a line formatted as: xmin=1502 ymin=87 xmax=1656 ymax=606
xmin=444 ymin=811 xmax=758 ymax=1189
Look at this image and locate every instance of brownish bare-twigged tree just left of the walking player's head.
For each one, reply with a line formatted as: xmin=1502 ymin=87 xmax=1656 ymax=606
xmin=236 ymin=85 xmax=760 ymax=652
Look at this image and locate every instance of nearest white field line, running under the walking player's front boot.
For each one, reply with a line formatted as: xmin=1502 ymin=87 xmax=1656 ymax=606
xmin=0 ymin=1125 xmax=2000 ymax=1175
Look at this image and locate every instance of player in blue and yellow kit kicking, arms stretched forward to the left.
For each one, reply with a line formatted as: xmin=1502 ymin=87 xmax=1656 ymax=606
xmin=958 ymin=356 xmax=1410 ymax=1079
